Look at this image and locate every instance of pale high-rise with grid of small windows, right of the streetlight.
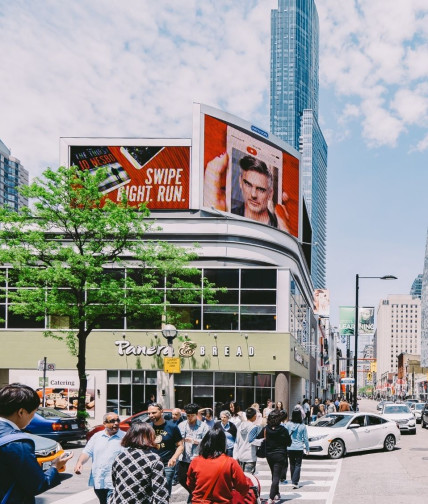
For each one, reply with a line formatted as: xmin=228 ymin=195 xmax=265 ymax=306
xmin=375 ymin=294 xmax=421 ymax=380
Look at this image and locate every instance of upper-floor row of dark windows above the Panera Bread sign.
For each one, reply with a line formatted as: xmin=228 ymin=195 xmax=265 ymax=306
xmin=0 ymin=268 xmax=277 ymax=331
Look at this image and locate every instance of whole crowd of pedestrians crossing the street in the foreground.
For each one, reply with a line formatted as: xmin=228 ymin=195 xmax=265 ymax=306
xmin=0 ymin=384 xmax=350 ymax=504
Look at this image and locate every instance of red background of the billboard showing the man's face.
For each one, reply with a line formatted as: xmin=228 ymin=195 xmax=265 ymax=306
xmin=204 ymin=115 xmax=299 ymax=237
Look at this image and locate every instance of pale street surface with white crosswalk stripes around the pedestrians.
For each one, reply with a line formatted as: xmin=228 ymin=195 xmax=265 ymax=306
xmin=36 ymin=399 xmax=428 ymax=504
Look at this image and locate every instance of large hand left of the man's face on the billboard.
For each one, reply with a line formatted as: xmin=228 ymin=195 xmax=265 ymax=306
xmin=204 ymin=152 xmax=229 ymax=211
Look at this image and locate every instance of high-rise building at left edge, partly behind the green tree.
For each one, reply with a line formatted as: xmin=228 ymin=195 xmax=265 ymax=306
xmin=0 ymin=140 xmax=28 ymax=210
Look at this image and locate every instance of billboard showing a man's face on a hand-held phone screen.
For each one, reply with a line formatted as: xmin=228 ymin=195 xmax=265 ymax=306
xmin=194 ymin=106 xmax=301 ymax=237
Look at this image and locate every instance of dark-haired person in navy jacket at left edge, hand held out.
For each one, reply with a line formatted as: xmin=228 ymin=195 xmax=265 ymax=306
xmin=0 ymin=383 xmax=73 ymax=504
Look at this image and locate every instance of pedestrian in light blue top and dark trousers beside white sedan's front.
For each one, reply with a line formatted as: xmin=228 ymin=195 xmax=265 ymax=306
xmin=286 ymin=409 xmax=309 ymax=489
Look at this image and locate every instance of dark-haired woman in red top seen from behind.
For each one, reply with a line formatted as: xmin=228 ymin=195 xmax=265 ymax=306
xmin=187 ymin=429 xmax=250 ymax=504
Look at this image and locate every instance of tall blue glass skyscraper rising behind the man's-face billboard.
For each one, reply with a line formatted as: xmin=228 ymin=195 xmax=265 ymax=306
xmin=270 ymin=0 xmax=327 ymax=288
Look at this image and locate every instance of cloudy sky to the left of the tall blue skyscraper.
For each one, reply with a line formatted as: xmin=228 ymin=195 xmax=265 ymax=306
xmin=0 ymin=0 xmax=276 ymax=174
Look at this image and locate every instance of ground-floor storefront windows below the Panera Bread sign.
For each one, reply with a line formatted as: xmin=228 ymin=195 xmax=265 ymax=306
xmin=107 ymin=370 xmax=275 ymax=416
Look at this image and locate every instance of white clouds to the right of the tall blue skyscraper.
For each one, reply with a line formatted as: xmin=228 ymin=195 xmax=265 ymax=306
xmin=317 ymin=0 xmax=428 ymax=146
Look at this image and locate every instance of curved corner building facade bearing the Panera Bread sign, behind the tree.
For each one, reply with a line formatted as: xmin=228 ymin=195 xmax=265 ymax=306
xmin=0 ymin=211 xmax=320 ymax=420
